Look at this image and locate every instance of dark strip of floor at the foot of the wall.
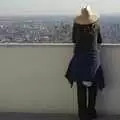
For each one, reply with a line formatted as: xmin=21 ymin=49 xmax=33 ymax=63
xmin=0 ymin=112 xmax=120 ymax=120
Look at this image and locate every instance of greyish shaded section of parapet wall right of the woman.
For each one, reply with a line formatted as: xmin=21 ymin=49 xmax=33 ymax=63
xmin=97 ymin=45 xmax=120 ymax=114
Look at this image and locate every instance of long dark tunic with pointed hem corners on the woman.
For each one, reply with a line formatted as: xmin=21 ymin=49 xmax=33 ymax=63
xmin=65 ymin=21 xmax=104 ymax=89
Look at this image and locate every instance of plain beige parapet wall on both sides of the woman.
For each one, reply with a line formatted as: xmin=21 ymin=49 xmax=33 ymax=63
xmin=0 ymin=45 xmax=120 ymax=114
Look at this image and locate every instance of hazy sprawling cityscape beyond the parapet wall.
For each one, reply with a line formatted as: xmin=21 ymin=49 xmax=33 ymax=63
xmin=0 ymin=15 xmax=120 ymax=43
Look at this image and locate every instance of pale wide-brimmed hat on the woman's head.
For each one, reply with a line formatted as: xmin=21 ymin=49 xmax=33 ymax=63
xmin=75 ymin=5 xmax=99 ymax=24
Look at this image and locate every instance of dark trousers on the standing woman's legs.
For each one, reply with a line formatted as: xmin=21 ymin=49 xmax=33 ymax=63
xmin=77 ymin=83 xmax=97 ymax=120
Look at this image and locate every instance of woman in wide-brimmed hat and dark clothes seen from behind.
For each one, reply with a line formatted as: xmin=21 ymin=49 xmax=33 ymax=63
xmin=65 ymin=5 xmax=105 ymax=120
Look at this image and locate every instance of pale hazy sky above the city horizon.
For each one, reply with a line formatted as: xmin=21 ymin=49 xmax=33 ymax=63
xmin=0 ymin=0 xmax=120 ymax=15
